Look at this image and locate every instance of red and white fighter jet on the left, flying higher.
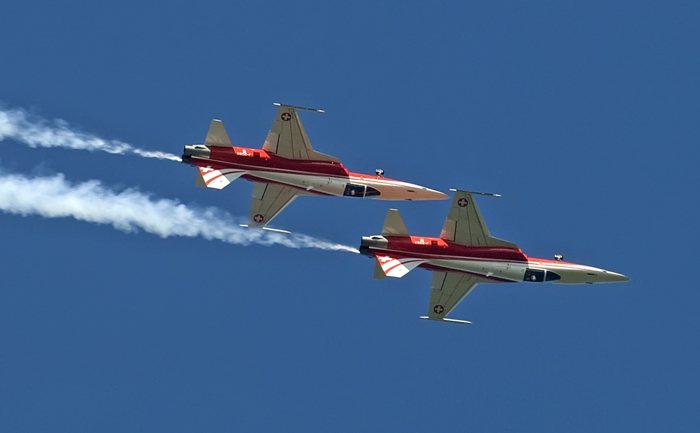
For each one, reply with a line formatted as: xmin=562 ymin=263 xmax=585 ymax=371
xmin=182 ymin=103 xmax=448 ymax=231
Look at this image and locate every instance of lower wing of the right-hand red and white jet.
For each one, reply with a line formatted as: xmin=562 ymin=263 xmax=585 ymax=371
xmin=425 ymin=271 xmax=488 ymax=323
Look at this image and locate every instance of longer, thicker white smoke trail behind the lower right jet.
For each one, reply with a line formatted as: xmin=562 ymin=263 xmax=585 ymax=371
xmin=0 ymin=173 xmax=357 ymax=253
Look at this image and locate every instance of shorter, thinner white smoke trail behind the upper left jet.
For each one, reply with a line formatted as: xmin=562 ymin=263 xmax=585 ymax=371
xmin=0 ymin=108 xmax=180 ymax=161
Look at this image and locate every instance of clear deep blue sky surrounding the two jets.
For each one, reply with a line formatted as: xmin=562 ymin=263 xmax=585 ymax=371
xmin=0 ymin=0 xmax=700 ymax=432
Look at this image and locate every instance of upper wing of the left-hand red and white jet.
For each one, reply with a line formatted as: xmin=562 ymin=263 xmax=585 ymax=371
xmin=263 ymin=104 xmax=340 ymax=162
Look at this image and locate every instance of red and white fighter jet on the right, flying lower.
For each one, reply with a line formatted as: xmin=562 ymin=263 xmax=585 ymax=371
xmin=360 ymin=190 xmax=629 ymax=324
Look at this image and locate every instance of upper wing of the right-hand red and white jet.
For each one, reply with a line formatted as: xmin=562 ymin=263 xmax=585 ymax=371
xmin=440 ymin=191 xmax=518 ymax=248
